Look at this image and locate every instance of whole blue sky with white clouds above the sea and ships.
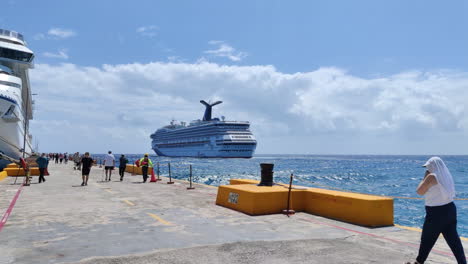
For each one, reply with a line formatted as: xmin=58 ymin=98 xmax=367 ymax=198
xmin=0 ymin=0 xmax=468 ymax=154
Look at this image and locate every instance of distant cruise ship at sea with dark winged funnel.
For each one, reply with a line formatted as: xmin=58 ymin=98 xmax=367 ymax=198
xmin=151 ymin=100 xmax=257 ymax=158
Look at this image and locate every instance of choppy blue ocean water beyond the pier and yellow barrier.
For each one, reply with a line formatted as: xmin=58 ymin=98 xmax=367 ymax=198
xmin=94 ymin=154 xmax=468 ymax=237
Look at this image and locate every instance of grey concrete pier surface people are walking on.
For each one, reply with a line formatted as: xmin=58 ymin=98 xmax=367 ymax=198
xmin=0 ymin=163 xmax=468 ymax=264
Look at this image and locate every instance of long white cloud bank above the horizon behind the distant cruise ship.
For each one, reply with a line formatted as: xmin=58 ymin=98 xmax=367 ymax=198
xmin=30 ymin=61 xmax=468 ymax=154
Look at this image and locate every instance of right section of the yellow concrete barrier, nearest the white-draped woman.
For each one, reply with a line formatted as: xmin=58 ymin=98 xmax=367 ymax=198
xmin=305 ymin=188 xmax=393 ymax=227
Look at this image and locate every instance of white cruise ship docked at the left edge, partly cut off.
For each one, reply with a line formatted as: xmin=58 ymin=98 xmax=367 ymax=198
xmin=0 ymin=29 xmax=34 ymax=169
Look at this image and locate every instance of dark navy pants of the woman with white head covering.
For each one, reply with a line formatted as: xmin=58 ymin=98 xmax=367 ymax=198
xmin=416 ymin=202 xmax=466 ymax=264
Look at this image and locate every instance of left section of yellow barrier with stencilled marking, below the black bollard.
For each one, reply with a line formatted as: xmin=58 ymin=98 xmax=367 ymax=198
xmin=216 ymin=184 xmax=305 ymax=215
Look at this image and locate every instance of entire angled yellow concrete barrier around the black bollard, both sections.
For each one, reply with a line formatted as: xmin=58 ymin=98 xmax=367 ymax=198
xmin=216 ymin=179 xmax=393 ymax=227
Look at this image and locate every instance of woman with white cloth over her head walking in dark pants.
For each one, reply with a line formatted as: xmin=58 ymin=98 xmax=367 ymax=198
xmin=408 ymin=157 xmax=466 ymax=264
